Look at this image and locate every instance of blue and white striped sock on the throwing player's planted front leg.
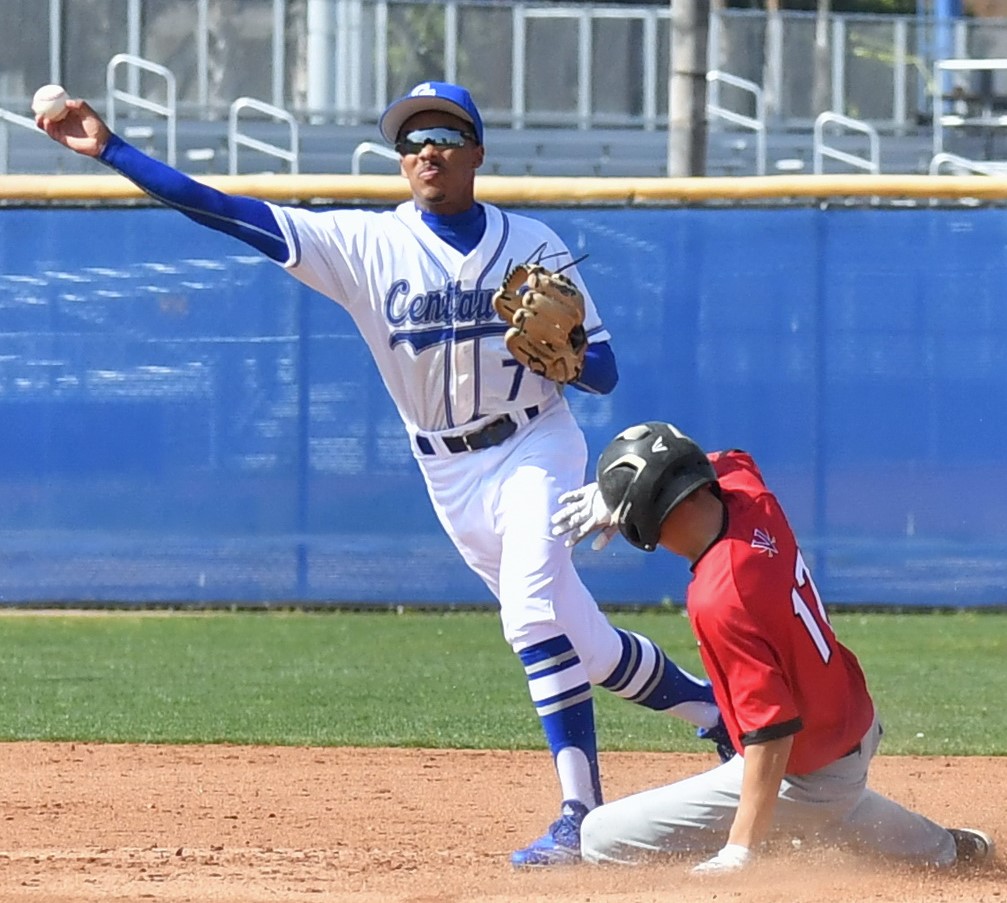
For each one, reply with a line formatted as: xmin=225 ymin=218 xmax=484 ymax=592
xmin=518 ymin=635 xmax=601 ymax=809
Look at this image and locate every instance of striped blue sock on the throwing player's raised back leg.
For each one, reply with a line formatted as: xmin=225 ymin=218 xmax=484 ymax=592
xmin=600 ymin=627 xmax=719 ymax=728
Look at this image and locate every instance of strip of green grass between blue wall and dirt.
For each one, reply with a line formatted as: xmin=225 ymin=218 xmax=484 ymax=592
xmin=0 ymin=609 xmax=1007 ymax=755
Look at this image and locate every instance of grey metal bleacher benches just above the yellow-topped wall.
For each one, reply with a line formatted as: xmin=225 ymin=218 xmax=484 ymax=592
xmin=0 ymin=110 xmax=958 ymax=176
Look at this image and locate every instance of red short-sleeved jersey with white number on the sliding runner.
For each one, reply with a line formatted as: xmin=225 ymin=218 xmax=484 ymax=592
xmin=686 ymin=451 xmax=874 ymax=774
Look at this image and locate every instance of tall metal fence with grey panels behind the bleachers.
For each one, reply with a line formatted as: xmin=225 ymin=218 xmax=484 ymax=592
xmin=0 ymin=0 xmax=1007 ymax=130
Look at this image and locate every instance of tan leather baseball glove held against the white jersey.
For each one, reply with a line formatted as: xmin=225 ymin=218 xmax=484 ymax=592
xmin=493 ymin=264 xmax=587 ymax=383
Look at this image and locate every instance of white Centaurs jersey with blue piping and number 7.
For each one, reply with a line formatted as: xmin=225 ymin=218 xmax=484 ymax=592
xmin=271 ymin=200 xmax=609 ymax=436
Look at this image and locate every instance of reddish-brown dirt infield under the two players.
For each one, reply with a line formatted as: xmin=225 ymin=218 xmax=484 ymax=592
xmin=0 ymin=743 xmax=1007 ymax=903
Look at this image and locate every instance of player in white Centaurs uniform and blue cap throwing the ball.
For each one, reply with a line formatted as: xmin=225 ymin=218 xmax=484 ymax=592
xmin=36 ymin=82 xmax=730 ymax=867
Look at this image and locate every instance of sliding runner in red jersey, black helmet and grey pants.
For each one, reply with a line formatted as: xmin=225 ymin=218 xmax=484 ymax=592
xmin=553 ymin=422 xmax=993 ymax=875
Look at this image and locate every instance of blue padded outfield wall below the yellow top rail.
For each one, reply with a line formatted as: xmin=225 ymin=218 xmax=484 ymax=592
xmin=0 ymin=206 xmax=1007 ymax=607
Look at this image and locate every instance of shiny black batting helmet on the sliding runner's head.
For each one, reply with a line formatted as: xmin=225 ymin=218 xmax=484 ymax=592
xmin=598 ymin=421 xmax=717 ymax=552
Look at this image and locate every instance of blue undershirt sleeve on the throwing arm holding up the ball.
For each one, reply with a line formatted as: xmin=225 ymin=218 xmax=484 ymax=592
xmin=99 ymin=135 xmax=290 ymax=264
